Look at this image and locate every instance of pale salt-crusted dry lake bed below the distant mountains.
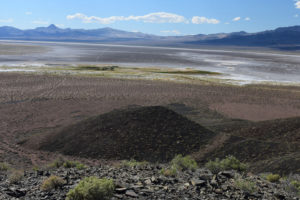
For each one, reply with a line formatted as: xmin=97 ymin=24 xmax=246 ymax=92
xmin=0 ymin=41 xmax=300 ymax=85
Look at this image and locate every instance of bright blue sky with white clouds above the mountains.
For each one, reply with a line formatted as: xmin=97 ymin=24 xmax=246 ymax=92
xmin=0 ymin=0 xmax=300 ymax=35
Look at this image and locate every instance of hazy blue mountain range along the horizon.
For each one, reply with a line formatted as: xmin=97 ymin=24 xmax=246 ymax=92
xmin=0 ymin=24 xmax=300 ymax=49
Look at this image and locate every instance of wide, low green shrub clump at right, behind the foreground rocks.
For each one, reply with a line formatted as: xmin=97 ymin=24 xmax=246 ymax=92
xmin=205 ymin=156 xmax=247 ymax=174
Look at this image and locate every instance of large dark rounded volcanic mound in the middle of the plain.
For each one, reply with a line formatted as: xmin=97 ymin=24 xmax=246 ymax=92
xmin=39 ymin=106 xmax=215 ymax=162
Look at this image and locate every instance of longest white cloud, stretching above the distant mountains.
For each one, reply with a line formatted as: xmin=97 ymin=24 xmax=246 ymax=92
xmin=67 ymin=12 xmax=188 ymax=24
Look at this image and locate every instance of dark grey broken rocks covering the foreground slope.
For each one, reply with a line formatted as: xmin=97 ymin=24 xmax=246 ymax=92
xmin=0 ymin=165 xmax=299 ymax=200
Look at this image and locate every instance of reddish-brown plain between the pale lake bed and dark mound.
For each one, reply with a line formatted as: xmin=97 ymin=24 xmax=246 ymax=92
xmin=0 ymin=73 xmax=300 ymax=171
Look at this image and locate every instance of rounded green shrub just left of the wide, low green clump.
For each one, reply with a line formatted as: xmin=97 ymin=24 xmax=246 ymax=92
xmin=171 ymin=155 xmax=198 ymax=170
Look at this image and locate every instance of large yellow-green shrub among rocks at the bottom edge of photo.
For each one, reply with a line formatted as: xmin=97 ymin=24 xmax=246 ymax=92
xmin=66 ymin=177 xmax=115 ymax=200
